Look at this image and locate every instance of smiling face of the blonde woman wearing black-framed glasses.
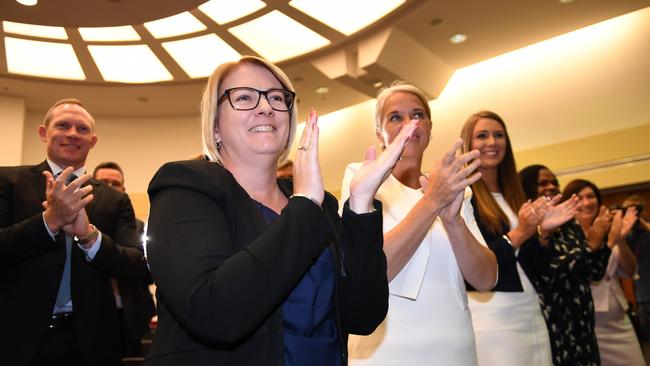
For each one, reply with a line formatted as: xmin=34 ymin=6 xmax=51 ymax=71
xmin=215 ymin=63 xmax=290 ymax=162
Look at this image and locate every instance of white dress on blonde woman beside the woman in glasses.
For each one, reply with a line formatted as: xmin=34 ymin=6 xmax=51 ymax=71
xmin=341 ymin=163 xmax=477 ymax=366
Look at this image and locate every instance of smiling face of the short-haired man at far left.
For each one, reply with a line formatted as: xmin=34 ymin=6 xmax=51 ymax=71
xmin=38 ymin=103 xmax=97 ymax=169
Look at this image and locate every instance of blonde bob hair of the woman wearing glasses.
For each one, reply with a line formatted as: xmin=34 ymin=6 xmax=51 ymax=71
xmin=201 ymin=56 xmax=298 ymax=164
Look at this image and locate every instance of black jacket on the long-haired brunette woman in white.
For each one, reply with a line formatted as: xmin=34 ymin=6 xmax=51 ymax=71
xmin=466 ymin=197 xmax=551 ymax=292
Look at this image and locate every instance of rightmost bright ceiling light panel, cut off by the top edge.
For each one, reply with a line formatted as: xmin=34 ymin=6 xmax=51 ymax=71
xmin=289 ymin=0 xmax=405 ymax=36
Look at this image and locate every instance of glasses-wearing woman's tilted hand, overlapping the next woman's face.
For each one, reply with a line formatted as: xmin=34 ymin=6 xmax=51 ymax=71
xmin=349 ymin=119 xmax=419 ymax=213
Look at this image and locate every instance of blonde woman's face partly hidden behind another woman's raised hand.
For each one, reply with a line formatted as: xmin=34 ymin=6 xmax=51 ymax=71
xmin=377 ymin=92 xmax=431 ymax=158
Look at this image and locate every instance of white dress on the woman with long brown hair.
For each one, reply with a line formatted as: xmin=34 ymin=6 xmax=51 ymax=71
xmin=467 ymin=193 xmax=553 ymax=366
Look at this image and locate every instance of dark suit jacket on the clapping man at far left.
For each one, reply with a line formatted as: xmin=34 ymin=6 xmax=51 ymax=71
xmin=0 ymin=162 xmax=145 ymax=365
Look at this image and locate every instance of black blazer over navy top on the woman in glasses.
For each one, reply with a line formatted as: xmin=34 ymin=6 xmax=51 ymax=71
xmin=146 ymin=161 xmax=388 ymax=366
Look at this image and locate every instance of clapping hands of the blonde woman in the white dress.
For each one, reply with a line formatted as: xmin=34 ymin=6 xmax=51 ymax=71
xmin=420 ymin=139 xmax=481 ymax=212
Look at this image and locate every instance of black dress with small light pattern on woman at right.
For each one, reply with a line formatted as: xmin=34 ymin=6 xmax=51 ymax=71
xmin=537 ymin=221 xmax=611 ymax=366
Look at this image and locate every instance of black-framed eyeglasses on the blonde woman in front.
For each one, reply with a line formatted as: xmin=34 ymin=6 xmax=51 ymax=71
xmin=218 ymin=87 xmax=296 ymax=112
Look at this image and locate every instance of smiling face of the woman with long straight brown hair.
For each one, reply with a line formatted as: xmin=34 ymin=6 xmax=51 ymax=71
xmin=470 ymin=118 xmax=508 ymax=169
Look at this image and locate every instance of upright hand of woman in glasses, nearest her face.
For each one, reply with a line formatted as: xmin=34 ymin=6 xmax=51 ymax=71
xmin=293 ymin=109 xmax=325 ymax=205
